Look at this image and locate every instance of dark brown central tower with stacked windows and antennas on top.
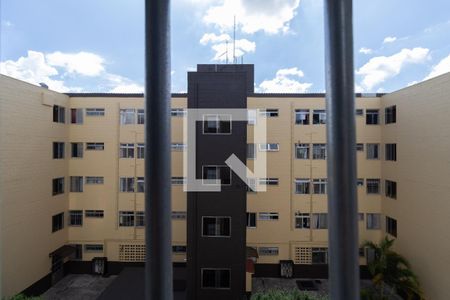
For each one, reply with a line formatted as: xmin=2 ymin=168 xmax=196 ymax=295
xmin=187 ymin=65 xmax=254 ymax=300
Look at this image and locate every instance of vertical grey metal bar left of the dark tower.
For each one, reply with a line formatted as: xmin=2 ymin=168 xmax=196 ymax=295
xmin=145 ymin=0 xmax=173 ymax=300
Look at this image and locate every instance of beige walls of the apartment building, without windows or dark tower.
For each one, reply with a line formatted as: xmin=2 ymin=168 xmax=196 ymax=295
xmin=0 ymin=74 xmax=450 ymax=299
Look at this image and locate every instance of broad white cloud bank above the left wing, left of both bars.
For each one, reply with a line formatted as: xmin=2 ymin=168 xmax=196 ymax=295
xmin=0 ymin=50 xmax=144 ymax=93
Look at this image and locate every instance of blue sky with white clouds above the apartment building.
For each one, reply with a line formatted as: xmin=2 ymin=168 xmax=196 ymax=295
xmin=0 ymin=0 xmax=450 ymax=92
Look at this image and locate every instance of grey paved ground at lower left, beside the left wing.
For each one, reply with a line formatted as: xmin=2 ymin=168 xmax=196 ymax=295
xmin=41 ymin=274 xmax=117 ymax=300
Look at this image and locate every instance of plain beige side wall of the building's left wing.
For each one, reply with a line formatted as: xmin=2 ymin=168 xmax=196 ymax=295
xmin=0 ymin=75 xmax=69 ymax=296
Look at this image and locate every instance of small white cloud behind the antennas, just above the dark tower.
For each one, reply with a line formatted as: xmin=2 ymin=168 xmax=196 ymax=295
xmin=200 ymin=33 xmax=256 ymax=61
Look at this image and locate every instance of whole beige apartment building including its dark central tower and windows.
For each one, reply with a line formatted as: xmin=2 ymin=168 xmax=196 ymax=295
xmin=0 ymin=65 xmax=450 ymax=299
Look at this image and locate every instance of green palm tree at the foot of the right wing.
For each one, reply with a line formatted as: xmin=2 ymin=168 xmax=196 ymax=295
xmin=362 ymin=236 xmax=424 ymax=300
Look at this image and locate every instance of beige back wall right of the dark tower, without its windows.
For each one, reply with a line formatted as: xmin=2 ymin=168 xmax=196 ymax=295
xmin=247 ymin=96 xmax=381 ymax=263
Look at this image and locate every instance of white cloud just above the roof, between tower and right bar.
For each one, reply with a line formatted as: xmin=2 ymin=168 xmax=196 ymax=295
xmin=257 ymin=68 xmax=312 ymax=93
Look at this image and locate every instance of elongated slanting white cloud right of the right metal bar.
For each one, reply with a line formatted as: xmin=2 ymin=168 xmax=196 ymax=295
xmin=356 ymin=48 xmax=429 ymax=91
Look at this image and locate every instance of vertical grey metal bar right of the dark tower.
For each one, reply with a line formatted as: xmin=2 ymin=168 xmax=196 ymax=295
xmin=325 ymin=0 xmax=359 ymax=300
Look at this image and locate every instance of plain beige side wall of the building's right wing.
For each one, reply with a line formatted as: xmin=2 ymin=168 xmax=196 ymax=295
xmin=381 ymin=73 xmax=450 ymax=299
